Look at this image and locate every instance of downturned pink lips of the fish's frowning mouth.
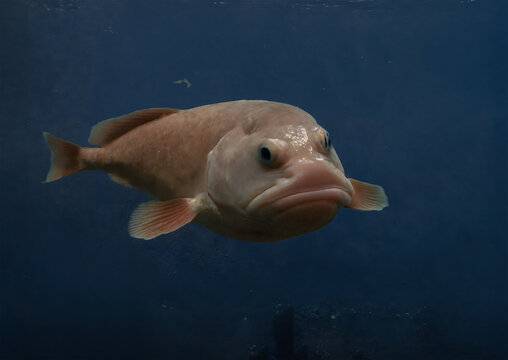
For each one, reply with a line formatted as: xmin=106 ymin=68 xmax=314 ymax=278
xmin=246 ymin=183 xmax=352 ymax=212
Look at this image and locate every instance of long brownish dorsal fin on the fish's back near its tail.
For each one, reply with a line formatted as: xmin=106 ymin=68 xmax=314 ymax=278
xmin=88 ymin=108 xmax=180 ymax=146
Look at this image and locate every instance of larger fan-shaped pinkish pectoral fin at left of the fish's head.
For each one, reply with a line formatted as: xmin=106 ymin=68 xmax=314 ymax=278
xmin=129 ymin=198 xmax=196 ymax=240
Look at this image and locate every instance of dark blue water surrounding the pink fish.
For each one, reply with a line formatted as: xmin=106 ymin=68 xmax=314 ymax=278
xmin=0 ymin=0 xmax=508 ymax=360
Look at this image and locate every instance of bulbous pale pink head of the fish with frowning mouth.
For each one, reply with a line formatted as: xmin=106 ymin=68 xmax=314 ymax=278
xmin=203 ymin=102 xmax=353 ymax=241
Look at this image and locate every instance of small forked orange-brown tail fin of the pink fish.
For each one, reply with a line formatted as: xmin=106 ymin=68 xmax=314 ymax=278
xmin=43 ymin=132 xmax=85 ymax=182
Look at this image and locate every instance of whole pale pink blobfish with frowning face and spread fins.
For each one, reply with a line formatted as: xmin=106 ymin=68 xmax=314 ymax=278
xmin=44 ymin=100 xmax=388 ymax=242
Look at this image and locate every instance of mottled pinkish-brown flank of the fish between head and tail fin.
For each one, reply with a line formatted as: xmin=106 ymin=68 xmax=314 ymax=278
xmin=82 ymin=105 xmax=230 ymax=200
